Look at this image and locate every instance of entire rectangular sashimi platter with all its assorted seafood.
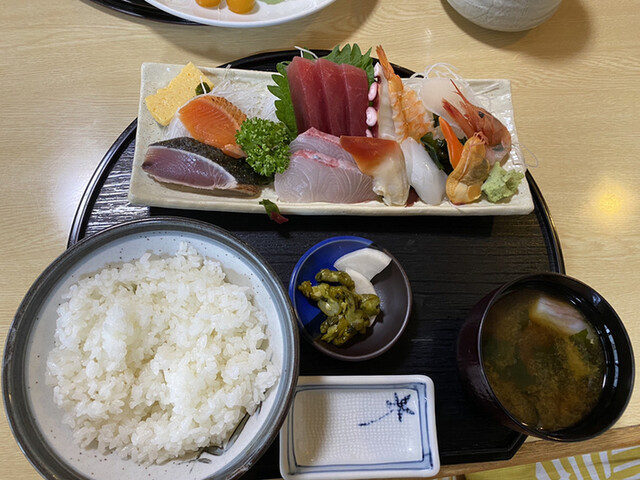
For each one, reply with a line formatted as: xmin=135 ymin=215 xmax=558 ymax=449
xmin=129 ymin=45 xmax=533 ymax=221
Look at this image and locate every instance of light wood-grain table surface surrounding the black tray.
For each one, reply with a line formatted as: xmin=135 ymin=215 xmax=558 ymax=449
xmin=0 ymin=0 xmax=640 ymax=480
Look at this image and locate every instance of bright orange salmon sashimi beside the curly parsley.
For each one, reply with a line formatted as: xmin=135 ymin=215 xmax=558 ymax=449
xmin=178 ymin=95 xmax=247 ymax=158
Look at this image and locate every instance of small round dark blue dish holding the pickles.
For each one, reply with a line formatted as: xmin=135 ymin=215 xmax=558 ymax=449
xmin=289 ymin=236 xmax=412 ymax=361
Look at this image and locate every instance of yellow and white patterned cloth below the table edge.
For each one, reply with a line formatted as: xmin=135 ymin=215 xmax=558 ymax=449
xmin=465 ymin=446 xmax=640 ymax=480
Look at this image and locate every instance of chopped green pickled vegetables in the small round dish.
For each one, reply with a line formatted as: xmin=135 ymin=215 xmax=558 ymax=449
xmin=298 ymin=268 xmax=380 ymax=345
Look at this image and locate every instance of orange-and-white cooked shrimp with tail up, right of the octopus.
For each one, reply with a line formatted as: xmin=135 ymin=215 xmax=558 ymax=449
xmin=376 ymin=46 xmax=433 ymax=142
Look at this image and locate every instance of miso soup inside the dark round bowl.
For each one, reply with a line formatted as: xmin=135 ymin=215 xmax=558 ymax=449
xmin=482 ymin=288 xmax=605 ymax=431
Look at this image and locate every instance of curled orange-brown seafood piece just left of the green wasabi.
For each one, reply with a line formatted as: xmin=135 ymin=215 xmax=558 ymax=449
xmin=446 ymin=132 xmax=491 ymax=205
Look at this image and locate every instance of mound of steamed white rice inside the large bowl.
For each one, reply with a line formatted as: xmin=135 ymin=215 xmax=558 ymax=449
xmin=47 ymin=243 xmax=279 ymax=463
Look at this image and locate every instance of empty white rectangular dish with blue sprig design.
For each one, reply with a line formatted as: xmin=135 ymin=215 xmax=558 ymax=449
xmin=280 ymin=375 xmax=440 ymax=480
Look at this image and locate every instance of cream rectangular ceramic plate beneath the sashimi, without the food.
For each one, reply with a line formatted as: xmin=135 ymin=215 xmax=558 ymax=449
xmin=129 ymin=63 xmax=533 ymax=216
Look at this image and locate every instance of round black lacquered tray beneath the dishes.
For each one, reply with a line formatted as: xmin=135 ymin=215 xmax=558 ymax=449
xmin=69 ymin=51 xmax=564 ymax=478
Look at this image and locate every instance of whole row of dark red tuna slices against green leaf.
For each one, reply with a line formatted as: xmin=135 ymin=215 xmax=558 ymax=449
xmin=287 ymin=57 xmax=369 ymax=136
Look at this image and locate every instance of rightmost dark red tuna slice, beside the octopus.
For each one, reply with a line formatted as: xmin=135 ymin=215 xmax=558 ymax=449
xmin=336 ymin=63 xmax=369 ymax=136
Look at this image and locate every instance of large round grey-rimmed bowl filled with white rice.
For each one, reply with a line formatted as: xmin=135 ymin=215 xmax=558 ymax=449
xmin=3 ymin=217 xmax=299 ymax=480
